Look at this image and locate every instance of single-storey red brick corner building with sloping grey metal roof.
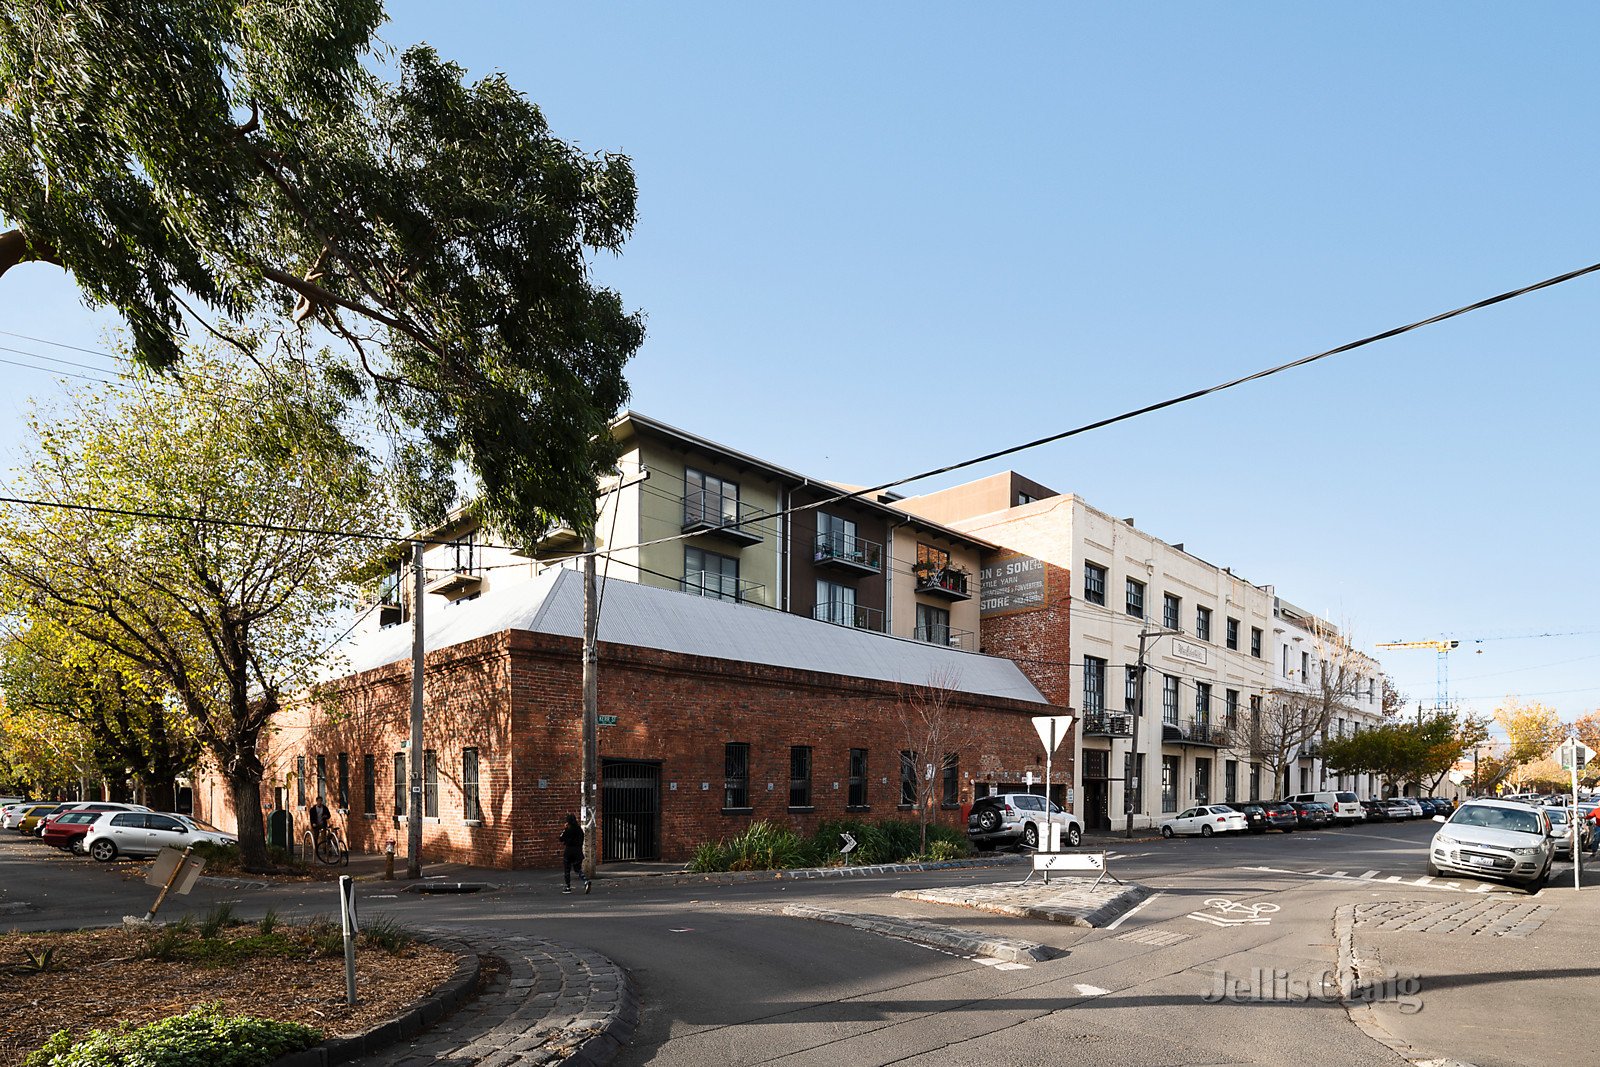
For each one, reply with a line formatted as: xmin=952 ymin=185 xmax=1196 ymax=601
xmin=197 ymin=569 xmax=1072 ymax=867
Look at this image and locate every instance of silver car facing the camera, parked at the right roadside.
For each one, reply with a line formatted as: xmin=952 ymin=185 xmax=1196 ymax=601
xmin=1427 ymin=800 xmax=1555 ymax=888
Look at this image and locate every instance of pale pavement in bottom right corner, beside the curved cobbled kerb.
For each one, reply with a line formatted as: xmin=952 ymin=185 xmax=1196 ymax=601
xmin=1334 ymin=881 xmax=1600 ymax=1067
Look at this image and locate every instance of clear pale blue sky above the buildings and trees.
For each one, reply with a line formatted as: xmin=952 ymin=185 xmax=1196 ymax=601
xmin=0 ymin=3 xmax=1600 ymax=717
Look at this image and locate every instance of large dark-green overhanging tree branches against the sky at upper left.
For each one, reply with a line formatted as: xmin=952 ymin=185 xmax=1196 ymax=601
xmin=0 ymin=0 xmax=643 ymax=539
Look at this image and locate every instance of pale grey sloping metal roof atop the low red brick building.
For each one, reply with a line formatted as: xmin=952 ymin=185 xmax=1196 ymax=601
xmin=339 ymin=568 xmax=1046 ymax=704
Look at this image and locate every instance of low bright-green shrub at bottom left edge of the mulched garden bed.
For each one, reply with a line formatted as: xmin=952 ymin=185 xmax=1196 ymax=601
xmin=22 ymin=1005 xmax=322 ymax=1067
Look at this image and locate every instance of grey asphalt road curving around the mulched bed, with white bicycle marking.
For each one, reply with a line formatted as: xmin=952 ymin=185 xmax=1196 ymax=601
xmin=0 ymin=822 xmax=1571 ymax=1067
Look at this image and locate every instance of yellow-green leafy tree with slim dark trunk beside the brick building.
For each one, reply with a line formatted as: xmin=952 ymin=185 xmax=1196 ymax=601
xmin=0 ymin=352 xmax=395 ymax=867
